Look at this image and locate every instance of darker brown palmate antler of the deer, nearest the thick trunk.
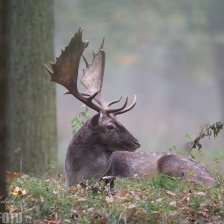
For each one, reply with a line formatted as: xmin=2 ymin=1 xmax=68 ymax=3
xmin=45 ymin=28 xmax=103 ymax=112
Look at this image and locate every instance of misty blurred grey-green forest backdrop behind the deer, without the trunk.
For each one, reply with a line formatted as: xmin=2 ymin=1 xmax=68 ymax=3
xmin=55 ymin=0 xmax=224 ymax=162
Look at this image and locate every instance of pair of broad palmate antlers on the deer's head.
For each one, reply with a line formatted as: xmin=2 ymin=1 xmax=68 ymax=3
xmin=45 ymin=28 xmax=136 ymax=115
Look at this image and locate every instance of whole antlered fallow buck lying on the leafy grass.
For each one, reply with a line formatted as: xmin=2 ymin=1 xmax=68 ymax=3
xmin=46 ymin=29 xmax=215 ymax=187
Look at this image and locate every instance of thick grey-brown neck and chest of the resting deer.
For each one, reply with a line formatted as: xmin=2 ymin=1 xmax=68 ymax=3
xmin=65 ymin=135 xmax=112 ymax=186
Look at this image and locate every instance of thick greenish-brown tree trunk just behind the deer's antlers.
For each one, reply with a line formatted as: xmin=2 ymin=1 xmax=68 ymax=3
xmin=7 ymin=0 xmax=57 ymax=174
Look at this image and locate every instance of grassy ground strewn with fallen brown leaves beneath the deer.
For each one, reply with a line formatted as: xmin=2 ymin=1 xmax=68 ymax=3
xmin=9 ymin=174 xmax=224 ymax=224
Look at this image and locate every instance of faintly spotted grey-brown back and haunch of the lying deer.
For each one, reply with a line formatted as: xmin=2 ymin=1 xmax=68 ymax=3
xmin=107 ymin=151 xmax=216 ymax=186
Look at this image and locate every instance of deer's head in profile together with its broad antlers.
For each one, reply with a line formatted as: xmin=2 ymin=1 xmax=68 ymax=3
xmin=45 ymin=28 xmax=140 ymax=151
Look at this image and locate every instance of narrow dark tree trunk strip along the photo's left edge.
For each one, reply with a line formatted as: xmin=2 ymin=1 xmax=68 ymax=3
xmin=0 ymin=0 xmax=7 ymax=214
